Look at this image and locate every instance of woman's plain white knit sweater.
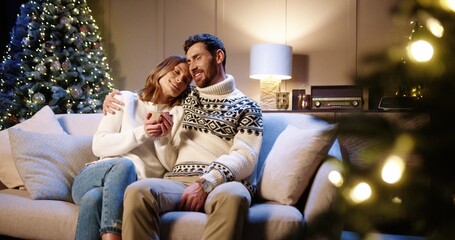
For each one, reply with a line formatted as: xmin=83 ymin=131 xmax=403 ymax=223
xmin=92 ymin=91 xmax=183 ymax=179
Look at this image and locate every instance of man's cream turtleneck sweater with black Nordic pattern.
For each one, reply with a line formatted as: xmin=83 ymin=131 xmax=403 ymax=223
xmin=170 ymin=75 xmax=263 ymax=195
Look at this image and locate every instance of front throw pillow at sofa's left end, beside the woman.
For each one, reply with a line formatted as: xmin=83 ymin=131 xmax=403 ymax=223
xmin=8 ymin=128 xmax=97 ymax=202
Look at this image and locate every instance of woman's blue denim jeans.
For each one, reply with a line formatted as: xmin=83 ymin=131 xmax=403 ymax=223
xmin=72 ymin=158 xmax=137 ymax=240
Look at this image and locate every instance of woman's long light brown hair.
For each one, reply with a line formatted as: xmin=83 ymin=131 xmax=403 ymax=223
xmin=138 ymin=56 xmax=191 ymax=106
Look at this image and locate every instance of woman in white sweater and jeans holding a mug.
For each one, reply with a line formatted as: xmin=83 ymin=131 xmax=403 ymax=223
xmin=72 ymin=56 xmax=191 ymax=240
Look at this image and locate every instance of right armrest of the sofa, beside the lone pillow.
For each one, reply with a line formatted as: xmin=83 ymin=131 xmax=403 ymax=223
xmin=304 ymin=158 xmax=342 ymax=228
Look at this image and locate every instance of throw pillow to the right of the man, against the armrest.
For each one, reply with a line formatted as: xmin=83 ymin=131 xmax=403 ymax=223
xmin=258 ymin=124 xmax=338 ymax=205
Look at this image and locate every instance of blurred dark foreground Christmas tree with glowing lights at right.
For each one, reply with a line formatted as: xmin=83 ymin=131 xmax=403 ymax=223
xmin=331 ymin=0 xmax=455 ymax=239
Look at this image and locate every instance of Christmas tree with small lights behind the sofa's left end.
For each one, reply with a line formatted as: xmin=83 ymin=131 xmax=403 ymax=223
xmin=0 ymin=0 xmax=113 ymax=130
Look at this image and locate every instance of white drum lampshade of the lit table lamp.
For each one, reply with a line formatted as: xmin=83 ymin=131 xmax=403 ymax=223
xmin=250 ymin=43 xmax=292 ymax=80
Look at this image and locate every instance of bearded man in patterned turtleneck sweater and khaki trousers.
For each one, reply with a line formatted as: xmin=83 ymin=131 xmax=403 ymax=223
xmin=104 ymin=34 xmax=262 ymax=240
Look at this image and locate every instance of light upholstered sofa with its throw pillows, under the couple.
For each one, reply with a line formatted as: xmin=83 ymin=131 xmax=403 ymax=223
xmin=0 ymin=107 xmax=344 ymax=240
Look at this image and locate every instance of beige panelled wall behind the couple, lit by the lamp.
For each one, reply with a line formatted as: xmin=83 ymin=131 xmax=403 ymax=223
xmin=88 ymin=0 xmax=402 ymax=107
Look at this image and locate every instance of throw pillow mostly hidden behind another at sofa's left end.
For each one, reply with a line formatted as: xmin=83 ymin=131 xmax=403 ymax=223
xmin=0 ymin=106 xmax=66 ymax=188
